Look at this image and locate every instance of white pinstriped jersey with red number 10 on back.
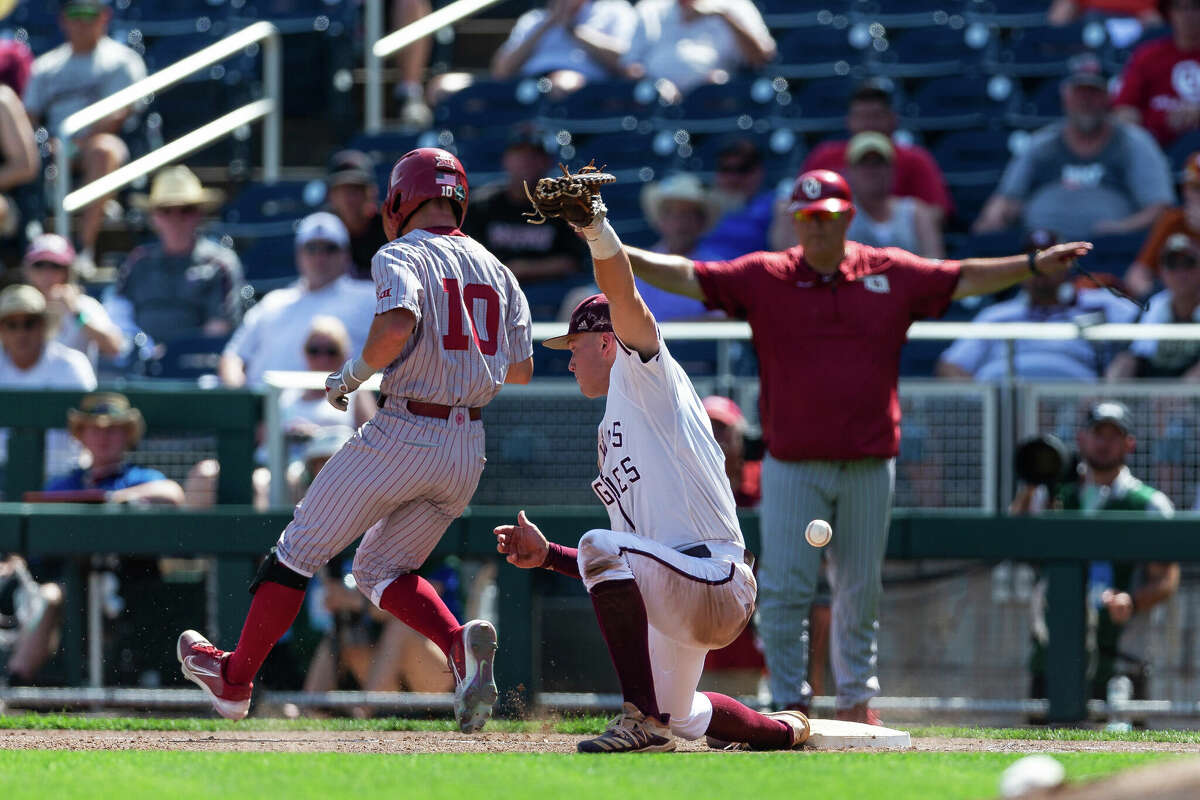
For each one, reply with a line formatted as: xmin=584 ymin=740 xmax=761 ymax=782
xmin=371 ymin=230 xmax=533 ymax=407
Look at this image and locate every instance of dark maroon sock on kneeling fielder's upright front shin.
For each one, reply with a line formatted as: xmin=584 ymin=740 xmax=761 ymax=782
xmin=590 ymin=578 xmax=666 ymax=722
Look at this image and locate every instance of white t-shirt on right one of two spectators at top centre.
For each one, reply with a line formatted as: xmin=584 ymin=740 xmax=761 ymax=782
xmin=622 ymin=0 xmax=770 ymax=92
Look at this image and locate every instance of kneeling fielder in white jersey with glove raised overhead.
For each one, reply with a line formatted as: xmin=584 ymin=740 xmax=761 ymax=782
xmin=496 ymin=168 xmax=809 ymax=753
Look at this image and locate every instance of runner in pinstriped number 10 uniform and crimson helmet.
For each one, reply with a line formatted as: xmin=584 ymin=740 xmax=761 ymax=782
xmin=178 ymin=148 xmax=533 ymax=733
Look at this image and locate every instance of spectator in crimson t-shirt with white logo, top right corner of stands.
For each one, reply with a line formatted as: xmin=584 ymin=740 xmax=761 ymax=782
xmin=1114 ymin=0 xmax=1200 ymax=148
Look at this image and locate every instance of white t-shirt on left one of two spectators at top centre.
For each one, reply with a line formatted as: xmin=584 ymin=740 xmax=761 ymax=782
xmin=500 ymin=0 xmax=637 ymax=80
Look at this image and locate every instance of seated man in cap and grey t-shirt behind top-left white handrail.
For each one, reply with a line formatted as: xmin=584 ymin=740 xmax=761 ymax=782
xmin=24 ymin=0 xmax=146 ymax=273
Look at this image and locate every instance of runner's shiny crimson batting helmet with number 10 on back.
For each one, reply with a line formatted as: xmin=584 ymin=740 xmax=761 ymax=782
xmin=380 ymin=148 xmax=470 ymax=239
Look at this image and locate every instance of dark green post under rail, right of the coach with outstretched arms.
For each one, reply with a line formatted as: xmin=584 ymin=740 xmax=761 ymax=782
xmin=1045 ymin=561 xmax=1087 ymax=723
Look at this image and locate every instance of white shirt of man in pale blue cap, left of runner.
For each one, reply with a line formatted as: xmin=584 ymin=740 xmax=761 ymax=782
xmin=224 ymin=276 xmax=376 ymax=386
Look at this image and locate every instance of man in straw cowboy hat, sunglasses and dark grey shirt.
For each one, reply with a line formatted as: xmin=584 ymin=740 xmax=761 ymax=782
xmin=104 ymin=166 xmax=242 ymax=343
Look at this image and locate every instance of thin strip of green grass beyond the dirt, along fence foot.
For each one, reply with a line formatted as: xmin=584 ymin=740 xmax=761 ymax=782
xmin=7 ymin=714 xmax=1200 ymax=744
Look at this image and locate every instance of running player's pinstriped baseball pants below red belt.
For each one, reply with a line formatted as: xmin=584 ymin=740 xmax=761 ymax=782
xmin=276 ymin=408 xmax=485 ymax=606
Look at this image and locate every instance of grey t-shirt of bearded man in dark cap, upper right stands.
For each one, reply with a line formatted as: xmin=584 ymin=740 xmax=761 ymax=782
xmin=997 ymin=122 xmax=1175 ymax=241
